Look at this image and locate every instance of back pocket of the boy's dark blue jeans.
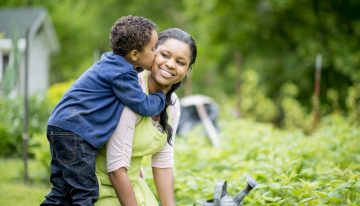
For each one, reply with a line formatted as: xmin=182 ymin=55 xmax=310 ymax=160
xmin=50 ymin=132 xmax=77 ymax=163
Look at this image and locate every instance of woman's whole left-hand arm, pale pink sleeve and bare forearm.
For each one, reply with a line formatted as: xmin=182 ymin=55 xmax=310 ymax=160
xmin=106 ymin=107 xmax=137 ymax=206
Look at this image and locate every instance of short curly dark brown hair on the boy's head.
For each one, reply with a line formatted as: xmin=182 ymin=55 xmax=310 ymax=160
xmin=110 ymin=15 xmax=156 ymax=56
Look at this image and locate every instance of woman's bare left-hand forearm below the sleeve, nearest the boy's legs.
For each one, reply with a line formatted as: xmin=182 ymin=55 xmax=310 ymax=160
xmin=109 ymin=167 xmax=137 ymax=206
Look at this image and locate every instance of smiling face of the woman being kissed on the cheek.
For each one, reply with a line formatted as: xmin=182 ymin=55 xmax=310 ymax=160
xmin=151 ymin=39 xmax=190 ymax=87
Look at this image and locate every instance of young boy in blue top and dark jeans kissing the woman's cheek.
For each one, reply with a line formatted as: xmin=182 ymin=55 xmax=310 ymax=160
xmin=41 ymin=16 xmax=165 ymax=205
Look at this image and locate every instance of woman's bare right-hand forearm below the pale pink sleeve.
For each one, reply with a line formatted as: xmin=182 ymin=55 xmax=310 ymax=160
xmin=153 ymin=167 xmax=175 ymax=206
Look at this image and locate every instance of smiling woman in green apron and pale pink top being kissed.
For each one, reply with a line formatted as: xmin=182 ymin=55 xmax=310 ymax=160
xmin=96 ymin=28 xmax=197 ymax=206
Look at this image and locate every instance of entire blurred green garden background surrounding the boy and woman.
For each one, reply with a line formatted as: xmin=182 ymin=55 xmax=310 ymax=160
xmin=0 ymin=0 xmax=360 ymax=205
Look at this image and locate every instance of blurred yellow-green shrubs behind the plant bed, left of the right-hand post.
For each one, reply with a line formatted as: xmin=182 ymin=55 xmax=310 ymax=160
xmin=216 ymin=70 xmax=312 ymax=132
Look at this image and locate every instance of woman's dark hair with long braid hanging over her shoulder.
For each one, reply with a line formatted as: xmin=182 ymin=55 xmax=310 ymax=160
xmin=156 ymin=28 xmax=197 ymax=145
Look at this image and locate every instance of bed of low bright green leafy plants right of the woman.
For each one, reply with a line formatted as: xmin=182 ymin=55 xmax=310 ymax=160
xmin=167 ymin=116 xmax=360 ymax=205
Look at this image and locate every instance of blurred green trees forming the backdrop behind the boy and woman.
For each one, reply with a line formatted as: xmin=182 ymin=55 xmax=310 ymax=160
xmin=0 ymin=0 xmax=360 ymax=116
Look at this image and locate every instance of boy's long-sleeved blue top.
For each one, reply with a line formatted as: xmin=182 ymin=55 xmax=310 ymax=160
xmin=48 ymin=52 xmax=165 ymax=148
